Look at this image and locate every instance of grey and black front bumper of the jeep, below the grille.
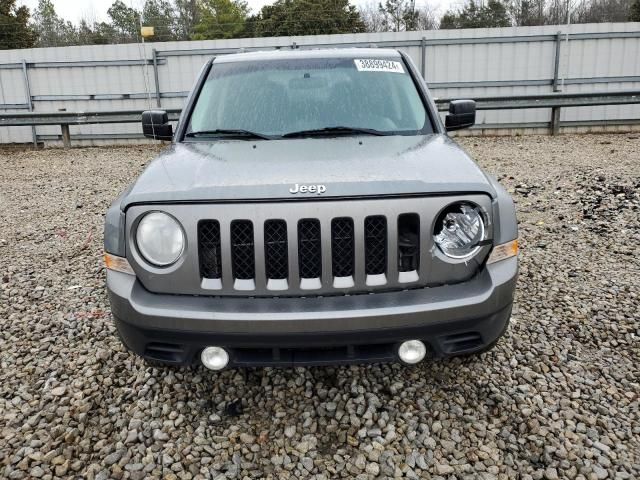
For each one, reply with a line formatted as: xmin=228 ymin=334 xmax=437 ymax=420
xmin=107 ymin=258 xmax=518 ymax=366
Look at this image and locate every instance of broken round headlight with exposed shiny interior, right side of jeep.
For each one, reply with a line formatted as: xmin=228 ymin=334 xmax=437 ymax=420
xmin=433 ymin=202 xmax=485 ymax=258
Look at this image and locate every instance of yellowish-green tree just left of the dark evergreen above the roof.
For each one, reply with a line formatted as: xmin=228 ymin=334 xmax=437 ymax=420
xmin=191 ymin=0 xmax=249 ymax=40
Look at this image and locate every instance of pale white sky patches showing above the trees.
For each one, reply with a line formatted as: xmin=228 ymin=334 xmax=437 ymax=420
xmin=16 ymin=0 xmax=460 ymax=23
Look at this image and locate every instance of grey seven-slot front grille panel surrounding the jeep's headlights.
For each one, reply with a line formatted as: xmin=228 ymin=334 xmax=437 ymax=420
xmin=127 ymin=194 xmax=493 ymax=296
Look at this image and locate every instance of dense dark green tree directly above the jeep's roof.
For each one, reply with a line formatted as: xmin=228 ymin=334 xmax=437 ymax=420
xmin=244 ymin=0 xmax=366 ymax=37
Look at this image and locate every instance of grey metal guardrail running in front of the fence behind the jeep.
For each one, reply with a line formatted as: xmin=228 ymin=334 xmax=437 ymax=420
xmin=0 ymin=90 xmax=640 ymax=147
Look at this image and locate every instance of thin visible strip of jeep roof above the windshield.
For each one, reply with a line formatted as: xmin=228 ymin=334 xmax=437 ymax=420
xmin=214 ymin=48 xmax=400 ymax=63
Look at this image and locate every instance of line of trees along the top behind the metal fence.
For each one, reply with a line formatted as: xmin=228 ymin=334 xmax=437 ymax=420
xmin=0 ymin=0 xmax=640 ymax=49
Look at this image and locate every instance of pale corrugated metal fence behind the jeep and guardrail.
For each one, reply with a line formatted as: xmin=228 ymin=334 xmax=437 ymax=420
xmin=0 ymin=23 xmax=640 ymax=143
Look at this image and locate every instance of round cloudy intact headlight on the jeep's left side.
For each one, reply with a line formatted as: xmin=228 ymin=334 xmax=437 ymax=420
xmin=136 ymin=212 xmax=184 ymax=267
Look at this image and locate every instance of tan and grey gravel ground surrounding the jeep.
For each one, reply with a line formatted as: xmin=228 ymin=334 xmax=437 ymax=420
xmin=0 ymin=134 xmax=640 ymax=480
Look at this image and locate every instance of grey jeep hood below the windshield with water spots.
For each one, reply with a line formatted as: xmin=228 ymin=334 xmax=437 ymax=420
xmin=121 ymin=134 xmax=495 ymax=210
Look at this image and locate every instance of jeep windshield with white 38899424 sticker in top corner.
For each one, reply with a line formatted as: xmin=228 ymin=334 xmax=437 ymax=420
xmin=186 ymin=58 xmax=433 ymax=138
